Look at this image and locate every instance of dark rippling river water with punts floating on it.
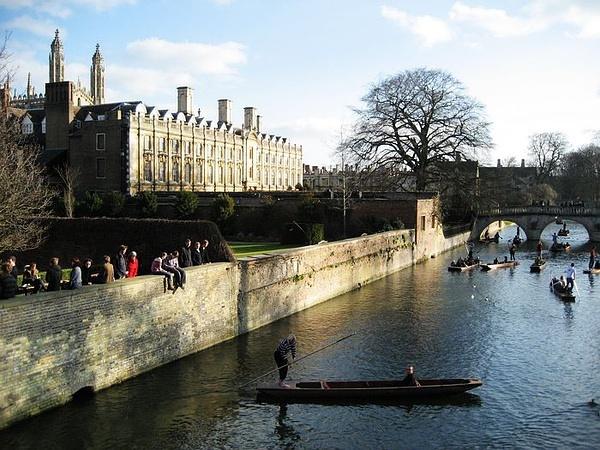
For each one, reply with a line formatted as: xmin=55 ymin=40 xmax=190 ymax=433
xmin=0 ymin=224 xmax=600 ymax=449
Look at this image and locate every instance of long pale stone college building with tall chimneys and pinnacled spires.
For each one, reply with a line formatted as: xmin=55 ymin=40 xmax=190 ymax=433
xmin=0 ymin=30 xmax=303 ymax=195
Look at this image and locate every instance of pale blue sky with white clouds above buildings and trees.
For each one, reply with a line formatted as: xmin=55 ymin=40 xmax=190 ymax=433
xmin=0 ymin=0 xmax=600 ymax=166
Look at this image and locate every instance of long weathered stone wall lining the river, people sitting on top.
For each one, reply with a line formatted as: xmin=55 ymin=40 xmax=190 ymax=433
xmin=0 ymin=229 xmax=468 ymax=428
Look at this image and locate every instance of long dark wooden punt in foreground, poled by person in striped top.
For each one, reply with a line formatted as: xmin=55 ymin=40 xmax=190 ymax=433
xmin=256 ymin=378 xmax=483 ymax=401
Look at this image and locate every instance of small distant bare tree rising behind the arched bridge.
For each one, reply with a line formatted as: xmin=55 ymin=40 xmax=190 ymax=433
xmin=529 ymin=132 xmax=569 ymax=183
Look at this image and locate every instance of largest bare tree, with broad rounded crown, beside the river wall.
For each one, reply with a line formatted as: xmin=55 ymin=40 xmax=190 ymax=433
xmin=346 ymin=68 xmax=492 ymax=191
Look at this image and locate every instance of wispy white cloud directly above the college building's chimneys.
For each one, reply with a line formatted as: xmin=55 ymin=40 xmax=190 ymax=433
xmin=127 ymin=38 xmax=246 ymax=75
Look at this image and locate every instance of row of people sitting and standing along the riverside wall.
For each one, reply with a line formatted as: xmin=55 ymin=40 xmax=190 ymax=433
xmin=0 ymin=239 xmax=210 ymax=300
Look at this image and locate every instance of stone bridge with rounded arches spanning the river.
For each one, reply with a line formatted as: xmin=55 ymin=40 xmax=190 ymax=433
xmin=471 ymin=206 xmax=600 ymax=242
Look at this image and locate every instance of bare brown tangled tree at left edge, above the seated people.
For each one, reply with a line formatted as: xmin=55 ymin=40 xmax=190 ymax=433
xmin=0 ymin=35 xmax=53 ymax=253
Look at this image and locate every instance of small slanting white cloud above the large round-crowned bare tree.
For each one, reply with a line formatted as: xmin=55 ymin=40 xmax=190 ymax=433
xmin=381 ymin=5 xmax=453 ymax=47
